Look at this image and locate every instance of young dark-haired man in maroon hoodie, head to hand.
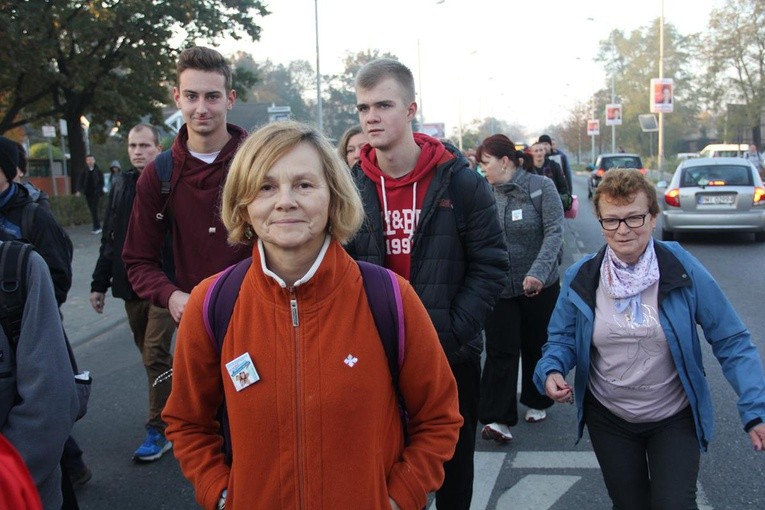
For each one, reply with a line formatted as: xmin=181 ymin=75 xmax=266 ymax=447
xmin=122 ymin=46 xmax=250 ymax=323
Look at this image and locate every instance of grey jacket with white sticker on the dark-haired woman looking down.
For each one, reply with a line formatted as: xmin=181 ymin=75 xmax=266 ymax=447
xmin=494 ymin=168 xmax=563 ymax=299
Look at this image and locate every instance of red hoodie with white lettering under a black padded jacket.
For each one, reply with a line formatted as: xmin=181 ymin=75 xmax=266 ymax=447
xmin=360 ymin=133 xmax=454 ymax=280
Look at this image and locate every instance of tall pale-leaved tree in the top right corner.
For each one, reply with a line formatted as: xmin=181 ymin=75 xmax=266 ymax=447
xmin=702 ymin=0 xmax=765 ymax=147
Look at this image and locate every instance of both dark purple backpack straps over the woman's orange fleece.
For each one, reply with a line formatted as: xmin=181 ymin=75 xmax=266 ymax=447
xmin=203 ymin=257 xmax=409 ymax=463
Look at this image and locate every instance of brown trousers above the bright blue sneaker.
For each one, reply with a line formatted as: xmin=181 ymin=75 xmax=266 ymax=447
xmin=125 ymin=299 xmax=175 ymax=433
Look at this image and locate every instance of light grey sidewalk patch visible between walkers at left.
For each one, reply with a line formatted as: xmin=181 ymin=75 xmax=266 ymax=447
xmin=61 ymin=225 xmax=127 ymax=346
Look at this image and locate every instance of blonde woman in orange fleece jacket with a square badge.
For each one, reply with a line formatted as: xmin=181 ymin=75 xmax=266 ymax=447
xmin=163 ymin=122 xmax=462 ymax=510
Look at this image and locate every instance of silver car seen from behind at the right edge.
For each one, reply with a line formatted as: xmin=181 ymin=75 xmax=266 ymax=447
xmin=661 ymin=158 xmax=765 ymax=242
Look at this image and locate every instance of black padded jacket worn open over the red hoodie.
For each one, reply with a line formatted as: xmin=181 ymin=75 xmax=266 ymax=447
xmin=346 ymin=145 xmax=508 ymax=365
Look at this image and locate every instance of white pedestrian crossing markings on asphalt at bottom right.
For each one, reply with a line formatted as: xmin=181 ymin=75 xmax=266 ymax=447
xmin=428 ymin=451 xmax=714 ymax=510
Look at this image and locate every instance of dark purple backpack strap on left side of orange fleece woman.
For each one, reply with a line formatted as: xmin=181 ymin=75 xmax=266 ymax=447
xmin=202 ymin=257 xmax=252 ymax=466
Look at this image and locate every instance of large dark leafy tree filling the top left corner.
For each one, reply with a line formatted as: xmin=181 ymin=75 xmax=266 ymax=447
xmin=0 ymin=0 xmax=268 ymax=189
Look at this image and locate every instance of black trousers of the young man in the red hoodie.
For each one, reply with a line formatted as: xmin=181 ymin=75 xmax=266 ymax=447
xmin=436 ymin=359 xmax=481 ymax=510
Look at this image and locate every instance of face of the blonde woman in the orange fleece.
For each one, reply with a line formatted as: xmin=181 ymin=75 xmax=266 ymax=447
xmin=247 ymin=142 xmax=329 ymax=257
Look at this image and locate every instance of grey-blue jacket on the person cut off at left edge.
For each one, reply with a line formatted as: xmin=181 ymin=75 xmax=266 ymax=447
xmin=0 ymin=252 xmax=79 ymax=510
